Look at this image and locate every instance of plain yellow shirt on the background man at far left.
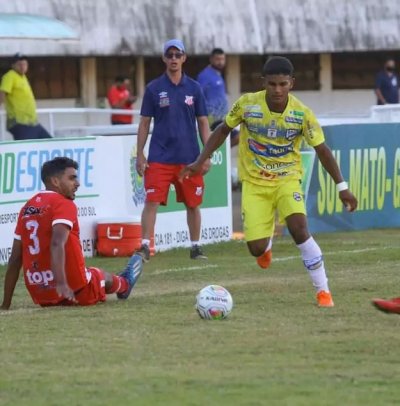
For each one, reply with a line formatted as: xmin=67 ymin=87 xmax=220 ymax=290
xmin=0 ymin=69 xmax=37 ymax=128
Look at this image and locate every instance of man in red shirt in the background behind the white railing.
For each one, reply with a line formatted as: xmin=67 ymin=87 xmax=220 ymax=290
xmin=107 ymin=75 xmax=136 ymax=124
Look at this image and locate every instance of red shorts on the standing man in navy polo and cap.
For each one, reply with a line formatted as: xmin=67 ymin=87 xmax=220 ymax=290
xmin=144 ymin=162 xmax=204 ymax=208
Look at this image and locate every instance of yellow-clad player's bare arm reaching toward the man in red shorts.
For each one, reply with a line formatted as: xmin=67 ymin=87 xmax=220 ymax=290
xmin=179 ymin=122 xmax=232 ymax=180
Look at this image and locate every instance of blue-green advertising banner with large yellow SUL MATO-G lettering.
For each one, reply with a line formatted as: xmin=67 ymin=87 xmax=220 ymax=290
xmin=307 ymin=123 xmax=400 ymax=232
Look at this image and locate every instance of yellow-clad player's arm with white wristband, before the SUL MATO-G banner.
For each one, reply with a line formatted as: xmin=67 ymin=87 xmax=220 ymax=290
xmin=314 ymin=143 xmax=358 ymax=211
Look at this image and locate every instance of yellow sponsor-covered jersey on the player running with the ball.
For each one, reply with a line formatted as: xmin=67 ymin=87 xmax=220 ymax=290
xmin=225 ymin=90 xmax=325 ymax=185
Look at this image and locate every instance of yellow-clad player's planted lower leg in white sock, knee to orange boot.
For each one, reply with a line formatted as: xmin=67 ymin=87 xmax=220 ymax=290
xmin=286 ymin=213 xmax=334 ymax=307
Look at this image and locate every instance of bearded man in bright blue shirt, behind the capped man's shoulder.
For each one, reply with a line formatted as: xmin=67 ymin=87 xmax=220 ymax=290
xmin=197 ymin=48 xmax=228 ymax=125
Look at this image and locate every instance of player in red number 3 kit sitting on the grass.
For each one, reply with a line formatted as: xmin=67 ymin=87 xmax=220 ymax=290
xmin=1 ymin=157 xmax=143 ymax=310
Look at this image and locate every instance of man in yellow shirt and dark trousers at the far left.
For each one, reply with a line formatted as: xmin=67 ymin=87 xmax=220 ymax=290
xmin=0 ymin=53 xmax=51 ymax=140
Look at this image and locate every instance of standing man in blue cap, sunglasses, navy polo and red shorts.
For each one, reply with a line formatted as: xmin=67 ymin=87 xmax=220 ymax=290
xmin=136 ymin=39 xmax=210 ymax=261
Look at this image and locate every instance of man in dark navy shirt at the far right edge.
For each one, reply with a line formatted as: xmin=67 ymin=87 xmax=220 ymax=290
xmin=375 ymin=58 xmax=400 ymax=105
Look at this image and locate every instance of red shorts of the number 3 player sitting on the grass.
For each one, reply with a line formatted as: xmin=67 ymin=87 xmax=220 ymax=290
xmin=39 ymin=268 xmax=106 ymax=307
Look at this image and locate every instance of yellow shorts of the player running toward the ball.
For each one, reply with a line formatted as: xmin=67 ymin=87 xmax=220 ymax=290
xmin=242 ymin=180 xmax=306 ymax=241
